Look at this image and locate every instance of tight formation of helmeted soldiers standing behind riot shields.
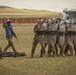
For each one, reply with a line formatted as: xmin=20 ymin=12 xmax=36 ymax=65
xmin=31 ymin=10 xmax=76 ymax=57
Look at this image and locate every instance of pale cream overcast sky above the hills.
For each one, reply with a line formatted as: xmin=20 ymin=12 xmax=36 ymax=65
xmin=0 ymin=0 xmax=76 ymax=12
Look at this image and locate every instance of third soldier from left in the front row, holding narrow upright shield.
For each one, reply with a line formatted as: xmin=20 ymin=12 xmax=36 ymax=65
xmin=58 ymin=21 xmax=65 ymax=56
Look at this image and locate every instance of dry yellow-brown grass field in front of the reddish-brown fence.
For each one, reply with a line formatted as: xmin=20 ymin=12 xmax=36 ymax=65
xmin=0 ymin=24 xmax=76 ymax=75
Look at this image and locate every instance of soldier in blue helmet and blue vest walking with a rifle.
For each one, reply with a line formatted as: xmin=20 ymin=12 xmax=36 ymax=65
xmin=3 ymin=19 xmax=17 ymax=54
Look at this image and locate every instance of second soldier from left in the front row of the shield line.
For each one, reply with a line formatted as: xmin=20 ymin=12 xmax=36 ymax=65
xmin=47 ymin=17 xmax=58 ymax=57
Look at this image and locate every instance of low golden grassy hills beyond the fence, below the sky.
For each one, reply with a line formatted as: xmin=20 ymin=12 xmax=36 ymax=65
xmin=0 ymin=6 xmax=60 ymax=17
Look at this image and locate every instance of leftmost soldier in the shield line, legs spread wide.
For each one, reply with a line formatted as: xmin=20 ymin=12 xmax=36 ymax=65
xmin=31 ymin=18 xmax=45 ymax=57
